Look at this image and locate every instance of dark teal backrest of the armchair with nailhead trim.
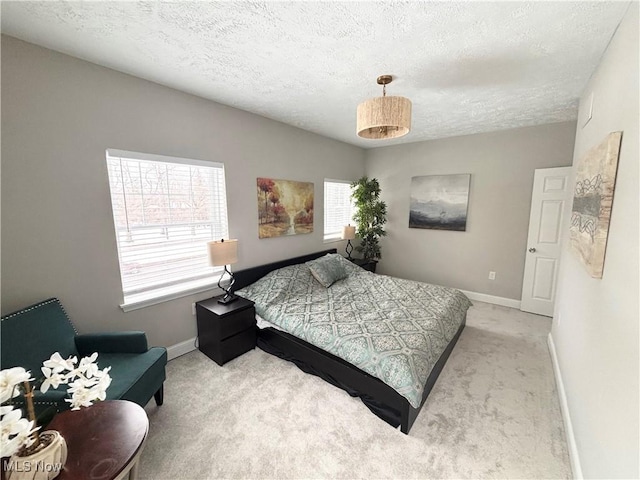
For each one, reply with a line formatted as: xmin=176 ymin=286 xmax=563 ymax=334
xmin=0 ymin=298 xmax=78 ymax=379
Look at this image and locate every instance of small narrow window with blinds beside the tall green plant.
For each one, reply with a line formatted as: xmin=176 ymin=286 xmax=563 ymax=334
xmin=324 ymin=179 xmax=355 ymax=241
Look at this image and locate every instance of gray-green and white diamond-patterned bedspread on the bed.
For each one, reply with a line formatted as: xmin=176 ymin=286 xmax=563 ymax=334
xmin=237 ymin=255 xmax=471 ymax=408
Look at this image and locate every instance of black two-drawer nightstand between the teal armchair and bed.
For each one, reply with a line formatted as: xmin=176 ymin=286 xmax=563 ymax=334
xmin=196 ymin=296 xmax=256 ymax=365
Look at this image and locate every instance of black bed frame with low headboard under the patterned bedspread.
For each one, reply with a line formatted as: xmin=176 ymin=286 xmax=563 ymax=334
xmin=234 ymin=248 xmax=466 ymax=434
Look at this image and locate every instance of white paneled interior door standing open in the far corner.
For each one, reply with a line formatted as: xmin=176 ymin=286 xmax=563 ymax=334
xmin=520 ymin=167 xmax=571 ymax=317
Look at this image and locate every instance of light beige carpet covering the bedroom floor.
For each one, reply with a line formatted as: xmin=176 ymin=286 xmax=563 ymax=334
xmin=139 ymin=302 xmax=571 ymax=480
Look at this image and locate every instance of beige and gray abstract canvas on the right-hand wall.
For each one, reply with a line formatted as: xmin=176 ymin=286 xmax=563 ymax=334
xmin=569 ymin=132 xmax=622 ymax=278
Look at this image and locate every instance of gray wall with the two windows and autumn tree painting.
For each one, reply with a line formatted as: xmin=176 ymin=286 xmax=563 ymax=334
xmin=2 ymin=36 xmax=364 ymax=346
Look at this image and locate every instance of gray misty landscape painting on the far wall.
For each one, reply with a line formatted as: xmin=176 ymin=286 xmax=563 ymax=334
xmin=409 ymin=174 xmax=471 ymax=232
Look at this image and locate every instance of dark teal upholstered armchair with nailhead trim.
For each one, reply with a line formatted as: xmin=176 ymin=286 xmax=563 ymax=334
xmin=0 ymin=298 xmax=167 ymax=423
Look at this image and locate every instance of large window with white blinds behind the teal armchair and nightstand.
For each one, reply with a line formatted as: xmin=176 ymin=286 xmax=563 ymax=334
xmin=107 ymin=149 xmax=228 ymax=311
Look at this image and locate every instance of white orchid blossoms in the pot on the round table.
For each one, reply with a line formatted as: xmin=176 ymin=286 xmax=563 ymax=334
xmin=0 ymin=352 xmax=111 ymax=457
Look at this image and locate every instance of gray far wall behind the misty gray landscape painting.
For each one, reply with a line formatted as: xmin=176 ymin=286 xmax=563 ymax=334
xmin=366 ymin=122 xmax=575 ymax=300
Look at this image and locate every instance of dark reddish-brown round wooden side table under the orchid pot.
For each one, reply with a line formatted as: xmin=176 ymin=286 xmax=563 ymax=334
xmin=46 ymin=400 xmax=149 ymax=480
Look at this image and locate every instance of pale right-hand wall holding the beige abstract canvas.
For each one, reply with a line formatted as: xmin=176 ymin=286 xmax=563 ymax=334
xmin=552 ymin=2 xmax=640 ymax=478
